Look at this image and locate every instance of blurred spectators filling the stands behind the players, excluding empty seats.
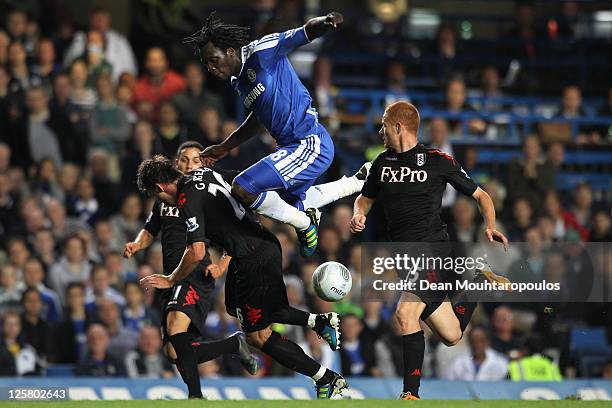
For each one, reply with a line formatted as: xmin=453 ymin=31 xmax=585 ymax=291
xmin=0 ymin=1 xmax=612 ymax=380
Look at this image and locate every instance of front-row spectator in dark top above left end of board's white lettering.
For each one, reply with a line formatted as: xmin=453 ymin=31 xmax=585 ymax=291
xmin=75 ymin=323 xmax=126 ymax=377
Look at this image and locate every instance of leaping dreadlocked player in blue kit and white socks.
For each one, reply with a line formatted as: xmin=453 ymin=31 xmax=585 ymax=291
xmin=183 ymin=12 xmax=370 ymax=256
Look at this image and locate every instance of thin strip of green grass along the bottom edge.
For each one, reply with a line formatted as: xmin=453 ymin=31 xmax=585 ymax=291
xmin=5 ymin=399 xmax=610 ymax=408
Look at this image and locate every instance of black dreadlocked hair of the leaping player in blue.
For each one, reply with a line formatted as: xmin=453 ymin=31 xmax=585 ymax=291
xmin=183 ymin=11 xmax=251 ymax=60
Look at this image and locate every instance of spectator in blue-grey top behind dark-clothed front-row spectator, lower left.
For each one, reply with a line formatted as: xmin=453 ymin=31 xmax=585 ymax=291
xmin=98 ymin=299 xmax=138 ymax=356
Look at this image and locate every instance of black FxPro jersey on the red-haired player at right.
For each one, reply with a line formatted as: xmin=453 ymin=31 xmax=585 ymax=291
xmin=361 ymin=144 xmax=478 ymax=242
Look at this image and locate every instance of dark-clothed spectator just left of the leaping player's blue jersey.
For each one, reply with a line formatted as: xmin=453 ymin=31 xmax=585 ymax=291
xmin=173 ymin=61 xmax=223 ymax=130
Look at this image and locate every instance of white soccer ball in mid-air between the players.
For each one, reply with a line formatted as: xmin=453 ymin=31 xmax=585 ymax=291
xmin=312 ymin=261 xmax=353 ymax=302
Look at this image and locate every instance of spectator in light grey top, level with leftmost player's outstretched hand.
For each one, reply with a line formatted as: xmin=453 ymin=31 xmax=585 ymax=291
xmin=49 ymin=235 xmax=91 ymax=303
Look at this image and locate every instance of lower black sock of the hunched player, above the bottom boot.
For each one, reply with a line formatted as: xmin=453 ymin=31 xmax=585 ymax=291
xmin=261 ymin=331 xmax=321 ymax=377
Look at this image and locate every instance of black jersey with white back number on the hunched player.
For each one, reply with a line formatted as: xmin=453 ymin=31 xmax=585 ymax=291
xmin=177 ymin=167 xmax=278 ymax=260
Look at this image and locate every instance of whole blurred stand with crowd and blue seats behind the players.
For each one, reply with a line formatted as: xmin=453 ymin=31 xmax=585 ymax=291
xmin=0 ymin=0 xmax=612 ymax=380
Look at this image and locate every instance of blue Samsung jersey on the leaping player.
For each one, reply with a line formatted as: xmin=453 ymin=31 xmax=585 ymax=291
xmin=231 ymin=27 xmax=319 ymax=146
